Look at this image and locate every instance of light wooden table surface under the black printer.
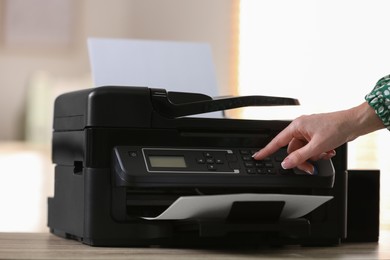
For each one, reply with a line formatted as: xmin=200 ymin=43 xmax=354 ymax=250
xmin=0 ymin=232 xmax=390 ymax=260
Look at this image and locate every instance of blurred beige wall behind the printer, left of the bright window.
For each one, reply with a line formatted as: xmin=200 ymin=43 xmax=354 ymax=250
xmin=0 ymin=0 xmax=235 ymax=141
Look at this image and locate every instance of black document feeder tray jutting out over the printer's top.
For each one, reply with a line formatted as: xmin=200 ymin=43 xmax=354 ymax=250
xmin=151 ymin=89 xmax=299 ymax=118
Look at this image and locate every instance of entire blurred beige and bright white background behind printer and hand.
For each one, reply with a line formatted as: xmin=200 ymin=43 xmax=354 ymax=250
xmin=0 ymin=0 xmax=390 ymax=232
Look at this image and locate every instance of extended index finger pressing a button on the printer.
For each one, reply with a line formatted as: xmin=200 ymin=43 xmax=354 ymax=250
xmin=252 ymin=127 xmax=294 ymax=160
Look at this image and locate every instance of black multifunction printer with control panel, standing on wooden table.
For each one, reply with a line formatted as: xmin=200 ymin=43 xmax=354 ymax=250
xmin=48 ymin=86 xmax=366 ymax=247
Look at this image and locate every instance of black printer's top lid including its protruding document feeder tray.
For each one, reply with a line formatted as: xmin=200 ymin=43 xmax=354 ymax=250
xmin=53 ymin=86 xmax=299 ymax=131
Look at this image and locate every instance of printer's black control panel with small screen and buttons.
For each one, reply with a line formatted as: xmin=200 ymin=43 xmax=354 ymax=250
xmin=115 ymin=146 xmax=326 ymax=175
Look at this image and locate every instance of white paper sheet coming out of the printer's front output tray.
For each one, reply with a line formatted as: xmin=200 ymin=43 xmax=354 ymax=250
xmin=144 ymin=194 xmax=333 ymax=220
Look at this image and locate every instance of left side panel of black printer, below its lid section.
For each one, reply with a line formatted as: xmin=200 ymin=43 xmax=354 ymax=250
xmin=48 ymin=131 xmax=85 ymax=238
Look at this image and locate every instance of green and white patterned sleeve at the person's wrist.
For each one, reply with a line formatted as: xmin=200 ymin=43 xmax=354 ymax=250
xmin=366 ymin=75 xmax=390 ymax=130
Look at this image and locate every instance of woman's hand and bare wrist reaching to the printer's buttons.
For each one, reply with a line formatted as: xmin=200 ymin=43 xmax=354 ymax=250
xmin=253 ymin=102 xmax=384 ymax=174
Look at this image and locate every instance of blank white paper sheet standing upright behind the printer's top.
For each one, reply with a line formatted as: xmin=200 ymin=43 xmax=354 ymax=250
xmin=88 ymin=38 xmax=223 ymax=118
